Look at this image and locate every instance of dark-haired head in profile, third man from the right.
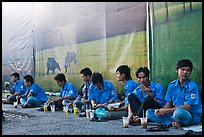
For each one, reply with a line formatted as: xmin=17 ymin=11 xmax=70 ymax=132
xmin=116 ymin=65 xmax=132 ymax=81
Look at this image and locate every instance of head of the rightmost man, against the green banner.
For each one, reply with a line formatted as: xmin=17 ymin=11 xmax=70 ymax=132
xmin=176 ymin=59 xmax=193 ymax=81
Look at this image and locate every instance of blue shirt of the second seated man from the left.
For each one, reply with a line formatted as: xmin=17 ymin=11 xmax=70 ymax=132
xmin=26 ymin=83 xmax=48 ymax=102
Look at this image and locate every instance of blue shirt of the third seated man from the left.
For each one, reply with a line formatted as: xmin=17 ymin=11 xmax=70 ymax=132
xmin=60 ymin=82 xmax=78 ymax=101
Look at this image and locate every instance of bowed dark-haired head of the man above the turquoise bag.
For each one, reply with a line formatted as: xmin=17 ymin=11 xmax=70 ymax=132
xmin=92 ymin=72 xmax=103 ymax=88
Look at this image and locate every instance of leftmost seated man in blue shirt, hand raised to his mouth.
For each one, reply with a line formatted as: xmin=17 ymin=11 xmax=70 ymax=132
xmin=2 ymin=72 xmax=26 ymax=104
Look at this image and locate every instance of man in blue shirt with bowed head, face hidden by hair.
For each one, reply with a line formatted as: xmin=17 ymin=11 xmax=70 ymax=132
xmin=88 ymin=72 xmax=117 ymax=109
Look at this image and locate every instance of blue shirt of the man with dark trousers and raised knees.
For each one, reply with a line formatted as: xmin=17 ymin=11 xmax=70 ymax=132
xmin=133 ymin=81 xmax=165 ymax=107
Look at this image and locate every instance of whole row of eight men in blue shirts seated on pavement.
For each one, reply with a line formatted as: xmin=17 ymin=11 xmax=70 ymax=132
xmin=3 ymin=59 xmax=202 ymax=128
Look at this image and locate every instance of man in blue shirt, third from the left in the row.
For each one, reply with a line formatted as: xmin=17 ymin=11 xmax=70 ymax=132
xmin=46 ymin=73 xmax=78 ymax=110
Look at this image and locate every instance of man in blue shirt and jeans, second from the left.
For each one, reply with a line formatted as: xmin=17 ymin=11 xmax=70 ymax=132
xmin=17 ymin=75 xmax=48 ymax=108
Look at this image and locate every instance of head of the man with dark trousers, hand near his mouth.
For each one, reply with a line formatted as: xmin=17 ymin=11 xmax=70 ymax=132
xmin=136 ymin=67 xmax=149 ymax=85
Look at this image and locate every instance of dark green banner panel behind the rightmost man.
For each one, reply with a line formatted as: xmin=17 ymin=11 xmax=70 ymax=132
xmin=150 ymin=2 xmax=203 ymax=94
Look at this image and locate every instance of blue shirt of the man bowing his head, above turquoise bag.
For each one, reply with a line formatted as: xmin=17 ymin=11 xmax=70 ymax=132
xmin=89 ymin=80 xmax=117 ymax=104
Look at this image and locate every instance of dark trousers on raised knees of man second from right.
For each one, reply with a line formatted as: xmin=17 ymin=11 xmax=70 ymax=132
xmin=128 ymin=94 xmax=162 ymax=117
